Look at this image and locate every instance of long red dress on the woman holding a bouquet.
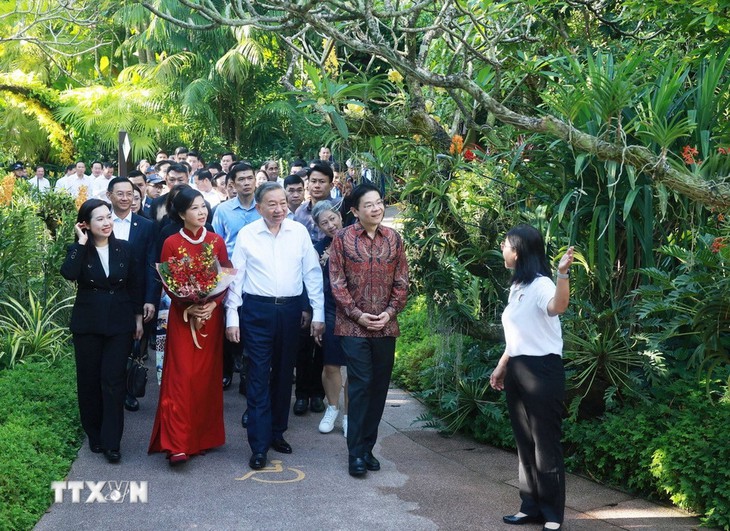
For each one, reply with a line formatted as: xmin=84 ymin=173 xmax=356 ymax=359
xmin=148 ymin=231 xmax=230 ymax=457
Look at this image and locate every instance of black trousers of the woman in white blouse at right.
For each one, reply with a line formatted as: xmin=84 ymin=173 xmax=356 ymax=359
xmin=504 ymin=354 xmax=565 ymax=523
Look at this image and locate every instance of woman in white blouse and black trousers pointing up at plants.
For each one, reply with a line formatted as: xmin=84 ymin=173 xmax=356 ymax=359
xmin=490 ymin=225 xmax=573 ymax=531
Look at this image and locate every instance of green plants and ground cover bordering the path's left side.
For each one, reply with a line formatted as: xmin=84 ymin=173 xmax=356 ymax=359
xmin=0 ymin=171 xmax=83 ymax=529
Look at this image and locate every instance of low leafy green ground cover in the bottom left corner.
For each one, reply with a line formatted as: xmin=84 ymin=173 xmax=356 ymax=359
xmin=0 ymin=356 xmax=83 ymax=529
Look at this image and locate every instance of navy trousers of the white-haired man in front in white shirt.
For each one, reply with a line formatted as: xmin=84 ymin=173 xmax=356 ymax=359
xmin=241 ymin=295 xmax=302 ymax=453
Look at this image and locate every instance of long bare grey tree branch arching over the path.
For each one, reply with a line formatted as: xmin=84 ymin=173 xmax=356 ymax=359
xmin=128 ymin=0 xmax=730 ymax=208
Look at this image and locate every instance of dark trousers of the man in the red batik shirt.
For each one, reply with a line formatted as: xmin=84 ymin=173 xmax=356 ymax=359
xmin=340 ymin=336 xmax=395 ymax=457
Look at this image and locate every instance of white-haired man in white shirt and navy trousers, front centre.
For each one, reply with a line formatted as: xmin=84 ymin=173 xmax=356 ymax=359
xmin=225 ymin=182 xmax=324 ymax=470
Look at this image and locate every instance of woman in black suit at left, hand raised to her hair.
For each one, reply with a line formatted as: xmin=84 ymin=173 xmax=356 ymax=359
xmin=61 ymin=199 xmax=144 ymax=463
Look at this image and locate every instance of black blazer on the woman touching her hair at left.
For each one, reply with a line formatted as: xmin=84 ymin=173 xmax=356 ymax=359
xmin=61 ymin=240 xmax=144 ymax=336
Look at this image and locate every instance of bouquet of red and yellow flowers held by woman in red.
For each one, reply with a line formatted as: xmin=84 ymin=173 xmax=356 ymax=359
xmin=157 ymin=243 xmax=237 ymax=348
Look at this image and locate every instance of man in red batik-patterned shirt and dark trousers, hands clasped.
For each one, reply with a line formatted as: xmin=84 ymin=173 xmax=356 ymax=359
xmin=329 ymin=184 xmax=408 ymax=476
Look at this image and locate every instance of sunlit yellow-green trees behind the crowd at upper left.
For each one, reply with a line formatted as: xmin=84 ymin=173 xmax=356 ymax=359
xmin=0 ymin=0 xmax=334 ymax=167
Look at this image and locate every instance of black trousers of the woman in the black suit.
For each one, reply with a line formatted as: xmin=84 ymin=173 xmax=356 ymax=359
xmin=73 ymin=332 xmax=132 ymax=450
